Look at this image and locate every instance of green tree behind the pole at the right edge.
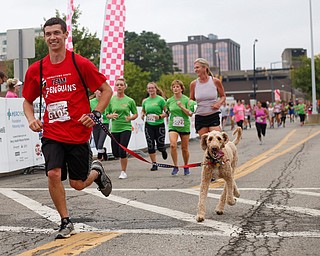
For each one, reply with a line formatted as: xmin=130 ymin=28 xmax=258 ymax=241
xmin=292 ymin=55 xmax=320 ymax=99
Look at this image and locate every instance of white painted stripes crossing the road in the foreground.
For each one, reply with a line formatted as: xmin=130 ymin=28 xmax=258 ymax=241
xmin=0 ymin=188 xmax=320 ymax=238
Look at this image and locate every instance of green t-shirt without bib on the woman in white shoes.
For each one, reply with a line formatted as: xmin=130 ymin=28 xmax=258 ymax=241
xmin=106 ymin=95 xmax=138 ymax=132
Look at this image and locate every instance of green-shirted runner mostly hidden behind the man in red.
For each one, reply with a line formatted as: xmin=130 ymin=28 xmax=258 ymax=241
xmin=90 ymin=90 xmax=109 ymax=161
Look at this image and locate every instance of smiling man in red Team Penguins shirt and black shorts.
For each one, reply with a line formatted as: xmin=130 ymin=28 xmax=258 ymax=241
xmin=22 ymin=18 xmax=113 ymax=238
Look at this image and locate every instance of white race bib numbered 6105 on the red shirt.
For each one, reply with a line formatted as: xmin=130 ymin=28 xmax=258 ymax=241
xmin=47 ymin=101 xmax=71 ymax=123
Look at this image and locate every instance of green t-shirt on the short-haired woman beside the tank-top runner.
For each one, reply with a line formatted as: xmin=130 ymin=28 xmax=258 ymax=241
xmin=167 ymin=95 xmax=194 ymax=132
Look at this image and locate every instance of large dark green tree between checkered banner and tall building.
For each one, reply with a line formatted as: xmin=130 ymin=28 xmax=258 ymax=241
xmin=124 ymin=31 xmax=173 ymax=81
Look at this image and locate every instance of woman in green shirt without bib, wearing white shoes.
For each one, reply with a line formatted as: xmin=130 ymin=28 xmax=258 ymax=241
xmin=106 ymin=78 xmax=138 ymax=179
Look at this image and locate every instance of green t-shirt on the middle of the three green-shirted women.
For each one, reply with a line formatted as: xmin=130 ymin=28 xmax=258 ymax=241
xmin=142 ymin=95 xmax=166 ymax=125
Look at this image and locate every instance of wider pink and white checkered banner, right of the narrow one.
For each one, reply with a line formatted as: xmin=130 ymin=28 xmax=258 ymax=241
xmin=100 ymin=0 xmax=126 ymax=90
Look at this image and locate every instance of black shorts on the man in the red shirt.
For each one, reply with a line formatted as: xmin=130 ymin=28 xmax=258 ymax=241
xmin=41 ymin=138 xmax=92 ymax=181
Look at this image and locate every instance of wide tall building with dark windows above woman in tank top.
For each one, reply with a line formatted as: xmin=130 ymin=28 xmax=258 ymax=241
xmin=167 ymin=34 xmax=241 ymax=74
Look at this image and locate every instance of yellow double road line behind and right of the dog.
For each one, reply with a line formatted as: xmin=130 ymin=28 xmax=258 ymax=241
xmin=193 ymin=129 xmax=320 ymax=188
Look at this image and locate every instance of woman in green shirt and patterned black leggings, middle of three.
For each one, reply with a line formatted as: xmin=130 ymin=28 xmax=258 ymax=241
xmin=141 ymin=82 xmax=168 ymax=171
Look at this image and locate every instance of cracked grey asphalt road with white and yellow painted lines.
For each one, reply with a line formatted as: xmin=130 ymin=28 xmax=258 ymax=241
xmin=0 ymin=122 xmax=320 ymax=256
